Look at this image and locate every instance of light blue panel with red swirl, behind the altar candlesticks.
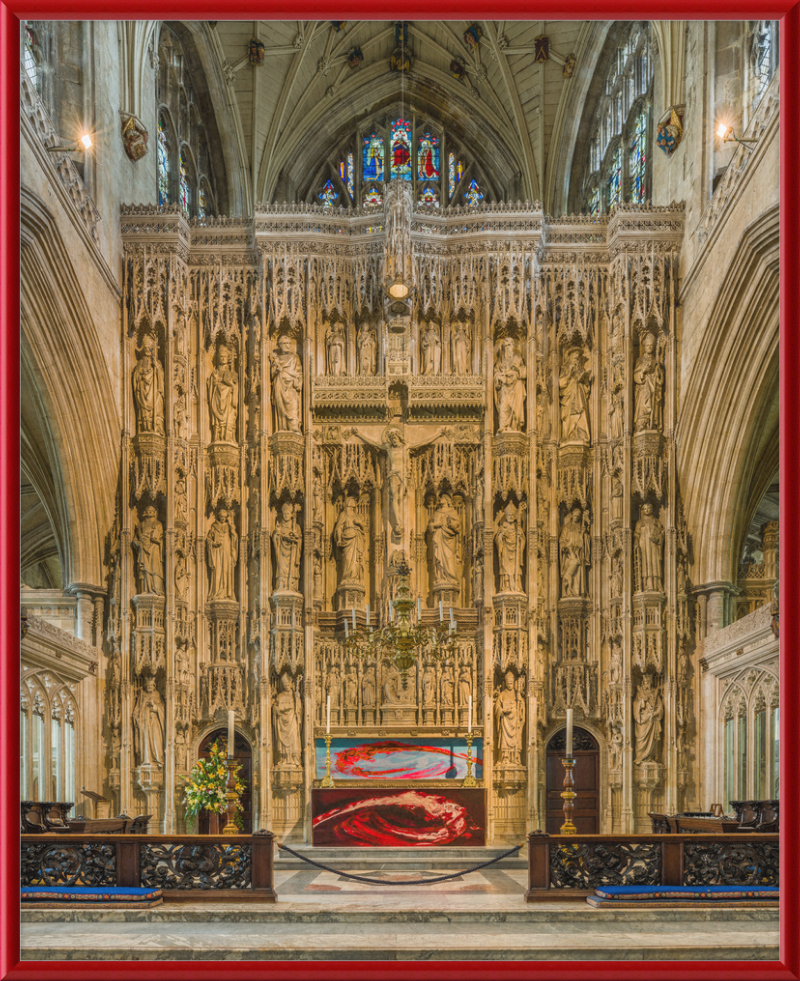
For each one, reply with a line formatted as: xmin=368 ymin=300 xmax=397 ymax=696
xmin=316 ymin=736 xmax=483 ymax=781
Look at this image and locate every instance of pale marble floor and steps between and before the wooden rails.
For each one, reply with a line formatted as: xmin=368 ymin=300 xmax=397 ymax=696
xmin=21 ymin=869 xmax=778 ymax=961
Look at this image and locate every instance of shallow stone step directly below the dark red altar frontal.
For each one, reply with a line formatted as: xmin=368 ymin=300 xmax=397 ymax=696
xmin=275 ymin=842 xmax=528 ymax=873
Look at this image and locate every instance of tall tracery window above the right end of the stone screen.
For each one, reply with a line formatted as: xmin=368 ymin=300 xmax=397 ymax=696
xmin=582 ymin=23 xmax=653 ymax=214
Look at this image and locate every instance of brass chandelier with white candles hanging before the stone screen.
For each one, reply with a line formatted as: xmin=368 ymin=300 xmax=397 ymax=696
xmin=344 ymin=563 xmax=458 ymax=683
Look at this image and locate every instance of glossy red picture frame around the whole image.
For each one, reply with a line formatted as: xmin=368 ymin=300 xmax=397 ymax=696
xmin=0 ymin=0 xmax=800 ymax=981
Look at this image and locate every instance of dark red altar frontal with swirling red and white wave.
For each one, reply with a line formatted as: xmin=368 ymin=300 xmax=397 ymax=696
xmin=311 ymin=787 xmax=486 ymax=847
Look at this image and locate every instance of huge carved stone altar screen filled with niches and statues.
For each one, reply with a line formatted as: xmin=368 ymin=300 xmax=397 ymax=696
xmin=111 ymin=185 xmax=694 ymax=840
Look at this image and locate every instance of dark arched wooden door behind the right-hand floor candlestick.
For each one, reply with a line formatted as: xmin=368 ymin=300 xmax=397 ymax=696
xmin=545 ymin=726 xmax=600 ymax=835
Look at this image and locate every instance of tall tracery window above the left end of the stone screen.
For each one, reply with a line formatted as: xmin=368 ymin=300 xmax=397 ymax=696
xmin=156 ymin=25 xmax=216 ymax=218
